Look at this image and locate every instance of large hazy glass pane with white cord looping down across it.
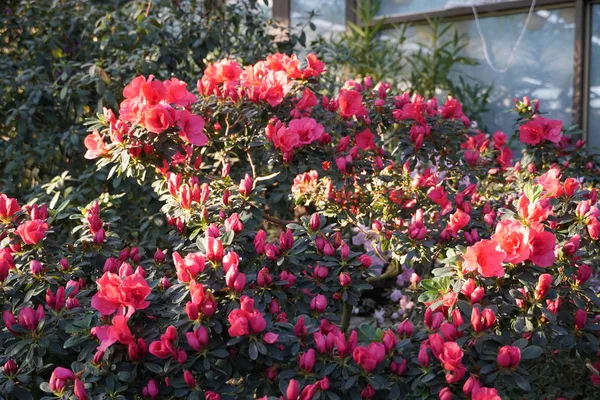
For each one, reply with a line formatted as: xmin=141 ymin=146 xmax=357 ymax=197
xmin=407 ymin=8 xmax=576 ymax=133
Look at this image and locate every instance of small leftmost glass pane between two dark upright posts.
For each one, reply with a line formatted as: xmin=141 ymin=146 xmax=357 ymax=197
xmin=290 ymin=0 xmax=346 ymax=40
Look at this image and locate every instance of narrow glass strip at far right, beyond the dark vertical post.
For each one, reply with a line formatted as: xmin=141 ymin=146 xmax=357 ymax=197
xmin=587 ymin=4 xmax=600 ymax=148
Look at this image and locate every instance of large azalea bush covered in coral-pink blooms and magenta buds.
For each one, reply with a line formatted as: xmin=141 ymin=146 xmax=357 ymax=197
xmin=0 ymin=54 xmax=600 ymax=400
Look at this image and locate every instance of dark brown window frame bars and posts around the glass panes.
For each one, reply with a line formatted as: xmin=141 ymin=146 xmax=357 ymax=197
xmin=273 ymin=0 xmax=598 ymax=139
